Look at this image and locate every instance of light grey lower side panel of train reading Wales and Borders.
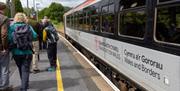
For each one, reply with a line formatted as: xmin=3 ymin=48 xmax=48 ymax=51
xmin=66 ymin=28 xmax=180 ymax=91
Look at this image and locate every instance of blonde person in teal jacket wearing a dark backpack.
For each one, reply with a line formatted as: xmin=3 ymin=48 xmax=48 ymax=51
xmin=8 ymin=13 xmax=37 ymax=91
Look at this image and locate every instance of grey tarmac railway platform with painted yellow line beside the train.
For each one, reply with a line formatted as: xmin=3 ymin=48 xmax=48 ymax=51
xmin=10 ymin=36 xmax=114 ymax=91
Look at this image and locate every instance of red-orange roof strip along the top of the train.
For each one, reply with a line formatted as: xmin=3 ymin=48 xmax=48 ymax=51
xmin=64 ymin=0 xmax=101 ymax=16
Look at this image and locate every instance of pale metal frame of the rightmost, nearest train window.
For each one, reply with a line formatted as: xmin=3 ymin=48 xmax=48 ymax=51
xmin=153 ymin=1 xmax=180 ymax=46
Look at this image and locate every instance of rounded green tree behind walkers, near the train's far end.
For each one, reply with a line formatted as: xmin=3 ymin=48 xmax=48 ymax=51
xmin=39 ymin=3 xmax=69 ymax=22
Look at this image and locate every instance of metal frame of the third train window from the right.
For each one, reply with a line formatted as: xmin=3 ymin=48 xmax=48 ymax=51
xmin=100 ymin=3 xmax=115 ymax=35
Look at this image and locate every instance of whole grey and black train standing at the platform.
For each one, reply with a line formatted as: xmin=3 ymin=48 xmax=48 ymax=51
xmin=64 ymin=0 xmax=180 ymax=91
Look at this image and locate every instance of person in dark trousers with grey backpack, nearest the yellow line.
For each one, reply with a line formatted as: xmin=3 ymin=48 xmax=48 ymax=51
xmin=43 ymin=21 xmax=59 ymax=72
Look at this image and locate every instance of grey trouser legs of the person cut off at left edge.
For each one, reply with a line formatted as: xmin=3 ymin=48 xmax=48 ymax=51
xmin=0 ymin=52 xmax=10 ymax=89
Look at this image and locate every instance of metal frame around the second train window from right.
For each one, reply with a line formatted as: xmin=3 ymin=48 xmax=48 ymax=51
xmin=118 ymin=6 xmax=148 ymax=40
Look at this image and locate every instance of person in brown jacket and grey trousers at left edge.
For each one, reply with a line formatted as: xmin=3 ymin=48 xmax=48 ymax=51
xmin=0 ymin=2 xmax=12 ymax=91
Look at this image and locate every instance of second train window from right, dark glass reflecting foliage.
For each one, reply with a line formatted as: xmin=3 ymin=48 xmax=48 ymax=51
xmin=119 ymin=10 xmax=147 ymax=38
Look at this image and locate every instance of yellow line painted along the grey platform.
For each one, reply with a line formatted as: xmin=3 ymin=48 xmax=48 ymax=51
xmin=56 ymin=58 xmax=64 ymax=91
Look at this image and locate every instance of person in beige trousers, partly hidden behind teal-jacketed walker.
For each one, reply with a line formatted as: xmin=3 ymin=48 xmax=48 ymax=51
xmin=27 ymin=15 xmax=40 ymax=73
